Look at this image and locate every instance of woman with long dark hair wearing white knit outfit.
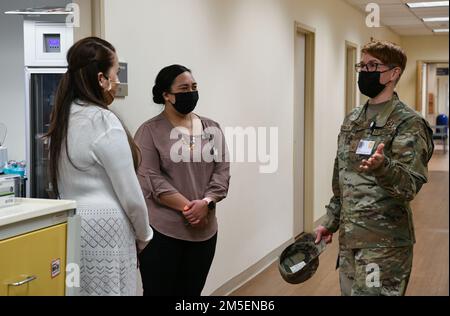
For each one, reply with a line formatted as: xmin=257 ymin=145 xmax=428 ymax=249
xmin=47 ymin=37 xmax=153 ymax=295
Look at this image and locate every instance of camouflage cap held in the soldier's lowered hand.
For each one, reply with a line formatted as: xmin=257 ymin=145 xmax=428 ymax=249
xmin=278 ymin=234 xmax=325 ymax=284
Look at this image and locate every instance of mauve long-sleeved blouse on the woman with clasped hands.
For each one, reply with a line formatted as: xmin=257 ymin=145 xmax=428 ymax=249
xmin=135 ymin=113 xmax=230 ymax=241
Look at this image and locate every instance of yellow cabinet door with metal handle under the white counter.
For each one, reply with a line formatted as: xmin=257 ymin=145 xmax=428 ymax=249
xmin=0 ymin=224 xmax=67 ymax=296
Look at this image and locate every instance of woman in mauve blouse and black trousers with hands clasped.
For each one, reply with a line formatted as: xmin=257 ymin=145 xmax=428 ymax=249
xmin=135 ymin=65 xmax=230 ymax=296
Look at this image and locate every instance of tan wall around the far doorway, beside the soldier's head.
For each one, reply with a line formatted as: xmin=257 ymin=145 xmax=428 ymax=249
xmin=398 ymin=35 xmax=448 ymax=108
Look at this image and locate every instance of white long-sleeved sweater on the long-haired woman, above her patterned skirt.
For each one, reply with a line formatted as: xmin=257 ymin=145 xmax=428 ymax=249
xmin=58 ymin=102 xmax=153 ymax=247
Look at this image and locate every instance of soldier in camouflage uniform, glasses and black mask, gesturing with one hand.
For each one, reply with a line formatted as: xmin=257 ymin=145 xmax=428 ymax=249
xmin=316 ymin=42 xmax=434 ymax=295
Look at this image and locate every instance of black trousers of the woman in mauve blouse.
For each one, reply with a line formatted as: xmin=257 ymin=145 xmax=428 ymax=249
xmin=139 ymin=228 xmax=217 ymax=296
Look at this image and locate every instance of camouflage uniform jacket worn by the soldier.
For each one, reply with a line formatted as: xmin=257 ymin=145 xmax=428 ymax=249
xmin=322 ymin=94 xmax=434 ymax=248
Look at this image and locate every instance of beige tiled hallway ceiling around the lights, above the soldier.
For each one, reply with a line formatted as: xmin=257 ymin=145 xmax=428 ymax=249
xmin=346 ymin=0 xmax=449 ymax=36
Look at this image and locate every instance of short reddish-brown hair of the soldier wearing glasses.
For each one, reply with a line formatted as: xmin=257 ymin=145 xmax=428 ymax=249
xmin=361 ymin=41 xmax=408 ymax=79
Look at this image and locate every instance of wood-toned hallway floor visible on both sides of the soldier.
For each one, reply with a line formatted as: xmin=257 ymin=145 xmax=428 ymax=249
xmin=232 ymin=151 xmax=449 ymax=296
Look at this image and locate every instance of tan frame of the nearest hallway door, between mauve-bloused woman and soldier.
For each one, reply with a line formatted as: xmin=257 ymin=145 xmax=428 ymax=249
xmin=292 ymin=22 xmax=316 ymax=238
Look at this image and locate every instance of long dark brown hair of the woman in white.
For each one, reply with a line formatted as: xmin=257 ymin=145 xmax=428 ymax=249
xmin=45 ymin=37 xmax=140 ymax=198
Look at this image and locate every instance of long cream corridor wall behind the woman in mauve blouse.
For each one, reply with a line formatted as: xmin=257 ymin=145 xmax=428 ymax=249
xmin=105 ymin=0 xmax=400 ymax=294
